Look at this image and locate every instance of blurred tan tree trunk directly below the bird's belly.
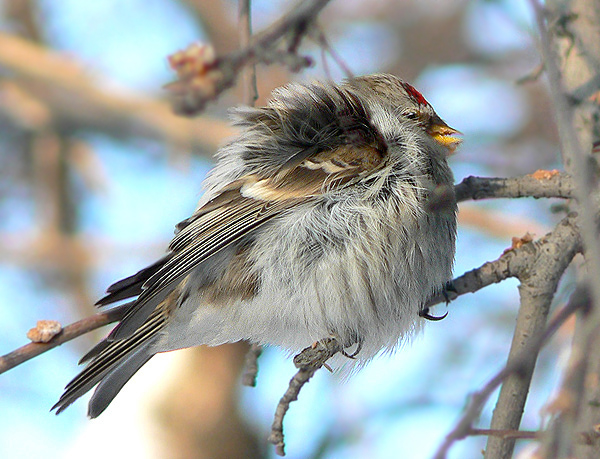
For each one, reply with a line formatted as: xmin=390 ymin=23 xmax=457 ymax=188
xmin=158 ymin=343 xmax=266 ymax=459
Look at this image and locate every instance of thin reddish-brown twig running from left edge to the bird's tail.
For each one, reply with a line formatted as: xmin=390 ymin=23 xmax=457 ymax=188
xmin=0 ymin=304 xmax=129 ymax=374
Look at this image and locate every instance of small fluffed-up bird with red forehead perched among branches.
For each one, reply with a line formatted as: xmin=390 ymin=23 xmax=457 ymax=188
xmin=54 ymin=74 xmax=460 ymax=418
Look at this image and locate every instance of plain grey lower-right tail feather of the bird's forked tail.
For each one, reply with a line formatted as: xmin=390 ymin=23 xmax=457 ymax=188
xmin=88 ymin=340 xmax=154 ymax=418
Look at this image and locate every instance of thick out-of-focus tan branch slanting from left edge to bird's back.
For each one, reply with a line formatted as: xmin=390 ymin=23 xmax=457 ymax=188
xmin=0 ymin=33 xmax=235 ymax=157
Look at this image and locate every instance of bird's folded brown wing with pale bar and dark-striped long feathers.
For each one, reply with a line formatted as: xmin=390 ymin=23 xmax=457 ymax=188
xmin=109 ymin=140 xmax=384 ymax=340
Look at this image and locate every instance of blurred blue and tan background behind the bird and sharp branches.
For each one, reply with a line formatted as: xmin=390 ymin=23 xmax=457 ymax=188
xmin=0 ymin=0 xmax=572 ymax=459
